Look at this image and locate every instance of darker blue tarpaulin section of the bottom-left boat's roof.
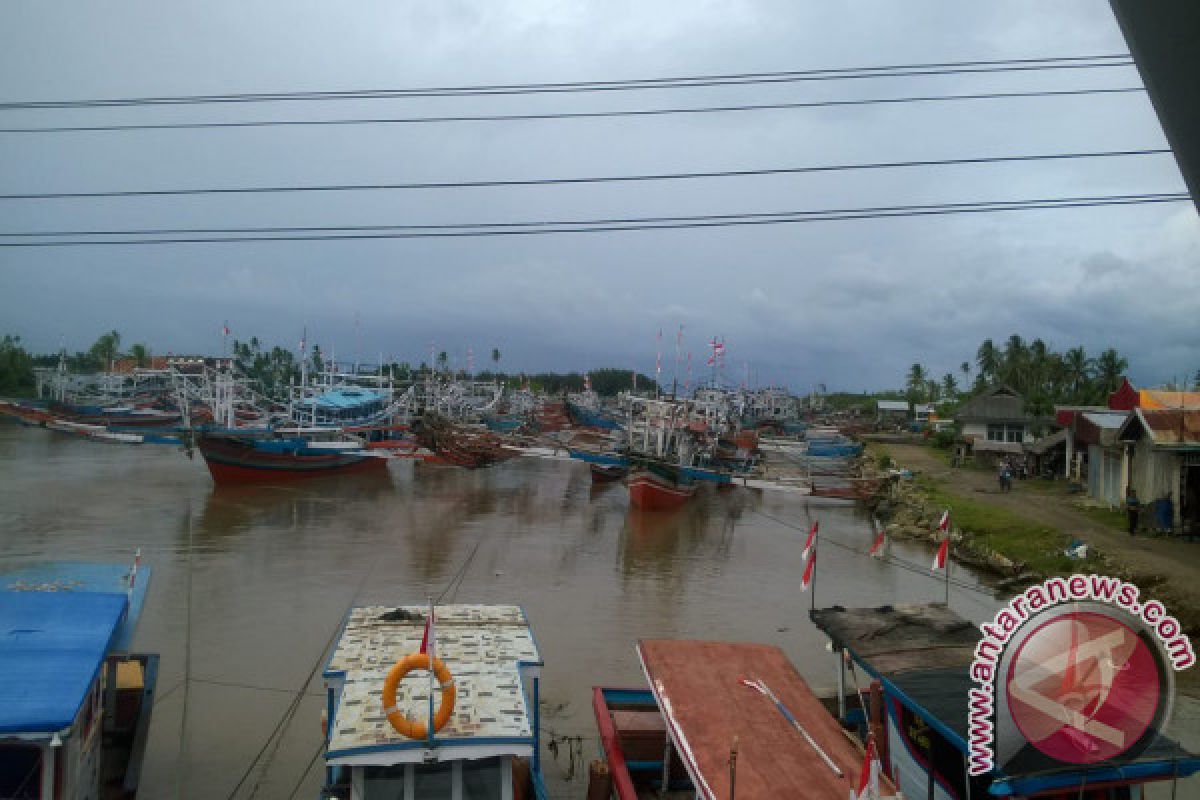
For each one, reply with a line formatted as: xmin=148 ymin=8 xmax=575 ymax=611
xmin=0 ymin=591 xmax=128 ymax=733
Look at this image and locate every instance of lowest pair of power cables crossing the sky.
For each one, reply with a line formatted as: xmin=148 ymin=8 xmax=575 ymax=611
xmin=0 ymin=192 xmax=1190 ymax=247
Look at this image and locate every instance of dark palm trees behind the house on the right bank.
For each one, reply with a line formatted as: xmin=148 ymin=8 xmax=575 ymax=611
xmin=905 ymin=333 xmax=1142 ymax=414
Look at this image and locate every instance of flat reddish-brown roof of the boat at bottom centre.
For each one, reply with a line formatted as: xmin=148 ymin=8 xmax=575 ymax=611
xmin=637 ymin=639 xmax=893 ymax=800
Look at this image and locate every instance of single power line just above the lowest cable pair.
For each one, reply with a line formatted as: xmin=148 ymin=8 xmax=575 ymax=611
xmin=0 ymin=148 xmax=1171 ymax=200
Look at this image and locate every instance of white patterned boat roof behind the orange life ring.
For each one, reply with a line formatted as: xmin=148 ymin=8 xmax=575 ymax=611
xmin=325 ymin=604 xmax=542 ymax=766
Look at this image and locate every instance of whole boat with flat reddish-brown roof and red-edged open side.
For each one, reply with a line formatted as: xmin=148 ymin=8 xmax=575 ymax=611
xmin=588 ymin=639 xmax=897 ymax=800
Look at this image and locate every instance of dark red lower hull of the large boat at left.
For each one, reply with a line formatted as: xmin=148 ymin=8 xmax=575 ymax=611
xmin=197 ymin=437 xmax=388 ymax=486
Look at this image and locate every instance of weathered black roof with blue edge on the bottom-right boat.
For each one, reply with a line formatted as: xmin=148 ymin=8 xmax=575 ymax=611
xmin=810 ymin=603 xmax=1200 ymax=798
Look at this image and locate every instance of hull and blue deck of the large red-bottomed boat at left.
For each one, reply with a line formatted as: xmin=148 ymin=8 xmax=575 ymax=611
xmin=196 ymin=429 xmax=388 ymax=485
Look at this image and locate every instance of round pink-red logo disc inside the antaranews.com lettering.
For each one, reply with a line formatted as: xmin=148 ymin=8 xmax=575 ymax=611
xmin=1006 ymin=612 xmax=1163 ymax=764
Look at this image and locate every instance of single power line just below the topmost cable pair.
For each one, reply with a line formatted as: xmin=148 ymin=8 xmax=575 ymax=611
xmin=0 ymin=86 xmax=1146 ymax=133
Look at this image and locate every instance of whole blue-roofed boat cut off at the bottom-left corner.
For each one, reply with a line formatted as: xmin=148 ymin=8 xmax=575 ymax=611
xmin=0 ymin=560 xmax=158 ymax=800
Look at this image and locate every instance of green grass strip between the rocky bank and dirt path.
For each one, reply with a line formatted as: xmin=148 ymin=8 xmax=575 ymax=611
xmin=918 ymin=479 xmax=1090 ymax=575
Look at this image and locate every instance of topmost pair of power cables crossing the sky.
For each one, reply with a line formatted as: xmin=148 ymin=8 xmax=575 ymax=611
xmin=0 ymin=55 xmax=1134 ymax=110
